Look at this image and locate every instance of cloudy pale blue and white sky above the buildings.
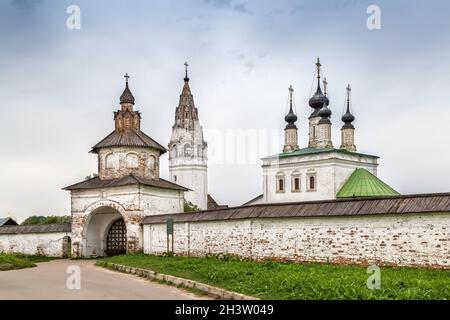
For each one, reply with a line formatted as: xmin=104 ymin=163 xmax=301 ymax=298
xmin=0 ymin=0 xmax=450 ymax=220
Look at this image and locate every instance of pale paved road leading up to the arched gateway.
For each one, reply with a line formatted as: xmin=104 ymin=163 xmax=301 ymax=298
xmin=0 ymin=259 xmax=204 ymax=300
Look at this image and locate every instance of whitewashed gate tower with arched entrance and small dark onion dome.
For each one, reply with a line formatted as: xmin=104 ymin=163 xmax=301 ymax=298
xmin=65 ymin=75 xmax=188 ymax=257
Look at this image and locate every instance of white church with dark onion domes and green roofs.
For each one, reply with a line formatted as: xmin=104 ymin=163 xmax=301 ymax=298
xmin=245 ymin=58 xmax=398 ymax=205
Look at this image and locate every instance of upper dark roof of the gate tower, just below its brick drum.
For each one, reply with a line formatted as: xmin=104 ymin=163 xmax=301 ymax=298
xmin=91 ymin=130 xmax=167 ymax=154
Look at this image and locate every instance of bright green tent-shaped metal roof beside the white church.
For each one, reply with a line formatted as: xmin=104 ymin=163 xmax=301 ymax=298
xmin=336 ymin=168 xmax=400 ymax=198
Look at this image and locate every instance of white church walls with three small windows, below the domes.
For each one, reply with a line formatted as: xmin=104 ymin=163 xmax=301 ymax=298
xmin=262 ymin=152 xmax=378 ymax=203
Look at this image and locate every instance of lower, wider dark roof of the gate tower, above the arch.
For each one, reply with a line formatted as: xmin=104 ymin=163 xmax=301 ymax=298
xmin=63 ymin=174 xmax=189 ymax=191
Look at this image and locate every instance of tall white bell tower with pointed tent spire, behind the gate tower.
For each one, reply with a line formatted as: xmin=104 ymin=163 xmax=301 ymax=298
xmin=168 ymin=62 xmax=208 ymax=209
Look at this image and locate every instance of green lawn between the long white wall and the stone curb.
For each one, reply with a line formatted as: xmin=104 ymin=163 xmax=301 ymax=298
xmin=98 ymin=254 xmax=450 ymax=300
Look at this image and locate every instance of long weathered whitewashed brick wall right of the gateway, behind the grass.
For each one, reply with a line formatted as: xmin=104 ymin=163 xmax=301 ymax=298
xmin=144 ymin=213 xmax=450 ymax=268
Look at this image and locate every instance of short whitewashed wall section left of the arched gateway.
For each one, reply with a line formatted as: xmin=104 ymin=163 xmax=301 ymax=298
xmin=0 ymin=232 xmax=70 ymax=257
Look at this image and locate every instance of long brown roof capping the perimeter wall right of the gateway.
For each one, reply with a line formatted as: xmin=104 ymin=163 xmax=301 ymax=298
xmin=142 ymin=193 xmax=450 ymax=224
